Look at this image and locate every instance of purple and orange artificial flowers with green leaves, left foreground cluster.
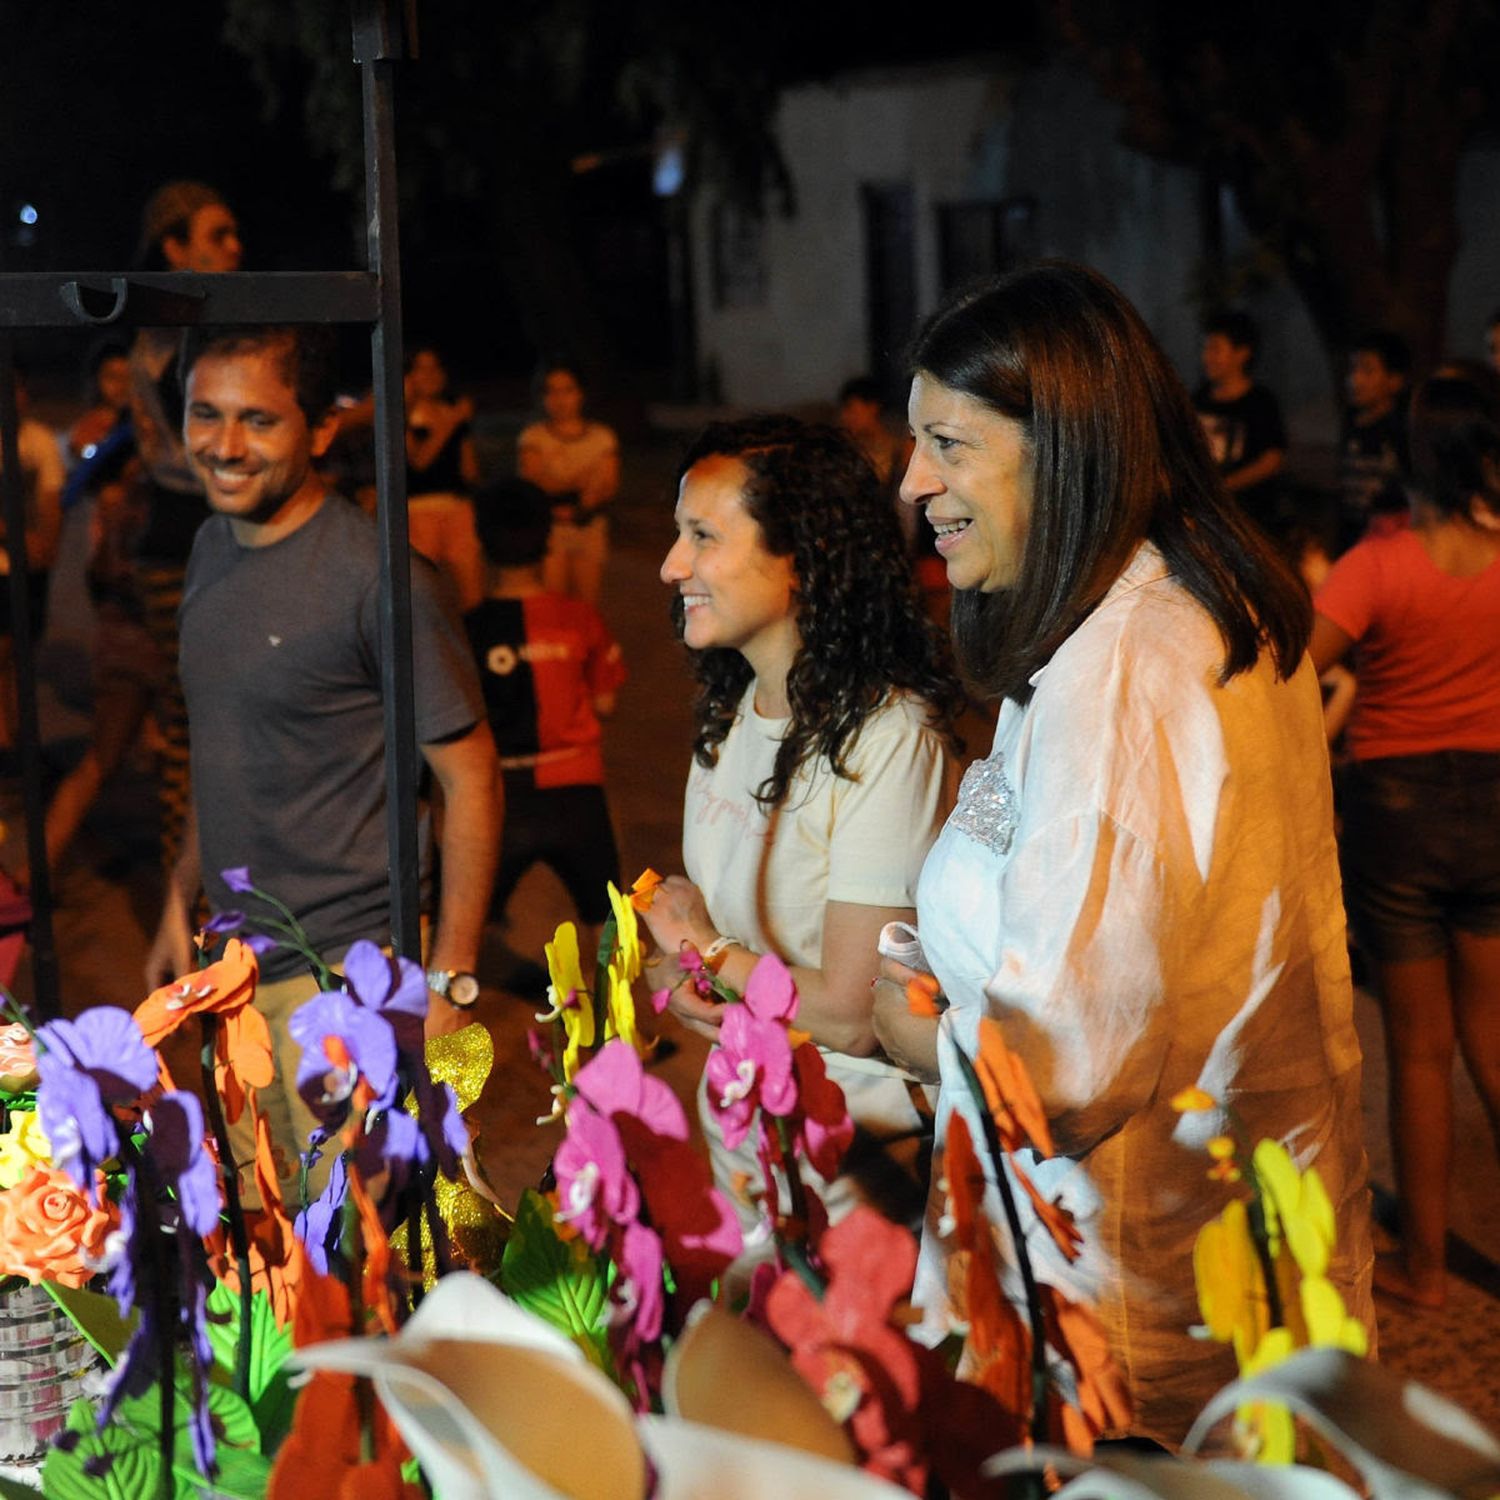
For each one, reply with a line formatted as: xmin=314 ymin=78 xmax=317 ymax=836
xmin=0 ymin=870 xmax=488 ymax=1500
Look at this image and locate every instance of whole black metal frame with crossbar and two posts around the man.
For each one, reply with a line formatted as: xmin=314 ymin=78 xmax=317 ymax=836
xmin=0 ymin=0 xmax=422 ymax=1019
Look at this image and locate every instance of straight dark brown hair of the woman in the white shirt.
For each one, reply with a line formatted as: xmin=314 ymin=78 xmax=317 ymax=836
xmin=911 ymin=261 xmax=1311 ymax=704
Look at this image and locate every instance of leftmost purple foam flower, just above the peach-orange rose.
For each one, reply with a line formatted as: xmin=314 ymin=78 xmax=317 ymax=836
xmin=36 ymin=1005 xmax=156 ymax=1202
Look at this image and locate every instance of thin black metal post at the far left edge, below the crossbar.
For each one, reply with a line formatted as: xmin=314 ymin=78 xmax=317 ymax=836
xmin=0 ymin=333 xmax=60 ymax=1020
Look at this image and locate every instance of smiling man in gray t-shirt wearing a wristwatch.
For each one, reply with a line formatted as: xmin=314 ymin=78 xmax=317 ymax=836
xmin=147 ymin=329 xmax=501 ymax=1200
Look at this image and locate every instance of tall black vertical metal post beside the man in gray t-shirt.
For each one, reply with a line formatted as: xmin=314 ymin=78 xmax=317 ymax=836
xmin=354 ymin=0 xmax=422 ymax=962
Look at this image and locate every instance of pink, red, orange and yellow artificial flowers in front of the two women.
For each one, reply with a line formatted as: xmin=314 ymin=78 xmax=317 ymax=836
xmin=504 ymin=872 xmax=1500 ymax=1496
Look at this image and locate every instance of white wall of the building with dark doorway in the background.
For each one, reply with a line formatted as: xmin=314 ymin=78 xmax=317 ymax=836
xmin=695 ymin=63 xmax=1500 ymax=438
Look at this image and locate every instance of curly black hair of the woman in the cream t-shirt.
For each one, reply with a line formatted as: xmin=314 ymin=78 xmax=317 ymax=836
xmin=672 ymin=417 xmax=965 ymax=810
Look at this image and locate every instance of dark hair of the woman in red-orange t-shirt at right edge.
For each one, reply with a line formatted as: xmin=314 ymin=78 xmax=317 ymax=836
xmin=1412 ymin=360 xmax=1500 ymax=518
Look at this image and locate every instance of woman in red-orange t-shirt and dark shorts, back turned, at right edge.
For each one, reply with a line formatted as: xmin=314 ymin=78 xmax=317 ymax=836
xmin=1311 ymin=365 xmax=1500 ymax=1307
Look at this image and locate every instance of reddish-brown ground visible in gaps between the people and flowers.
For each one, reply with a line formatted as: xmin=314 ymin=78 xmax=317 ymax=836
xmin=8 ymin=423 xmax=1500 ymax=1428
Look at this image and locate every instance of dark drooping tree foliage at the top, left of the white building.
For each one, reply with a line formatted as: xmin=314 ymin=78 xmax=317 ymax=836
xmin=225 ymin=0 xmax=789 ymax=368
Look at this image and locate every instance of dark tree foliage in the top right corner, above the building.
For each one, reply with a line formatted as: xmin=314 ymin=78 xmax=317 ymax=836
xmin=1049 ymin=0 xmax=1500 ymax=375
